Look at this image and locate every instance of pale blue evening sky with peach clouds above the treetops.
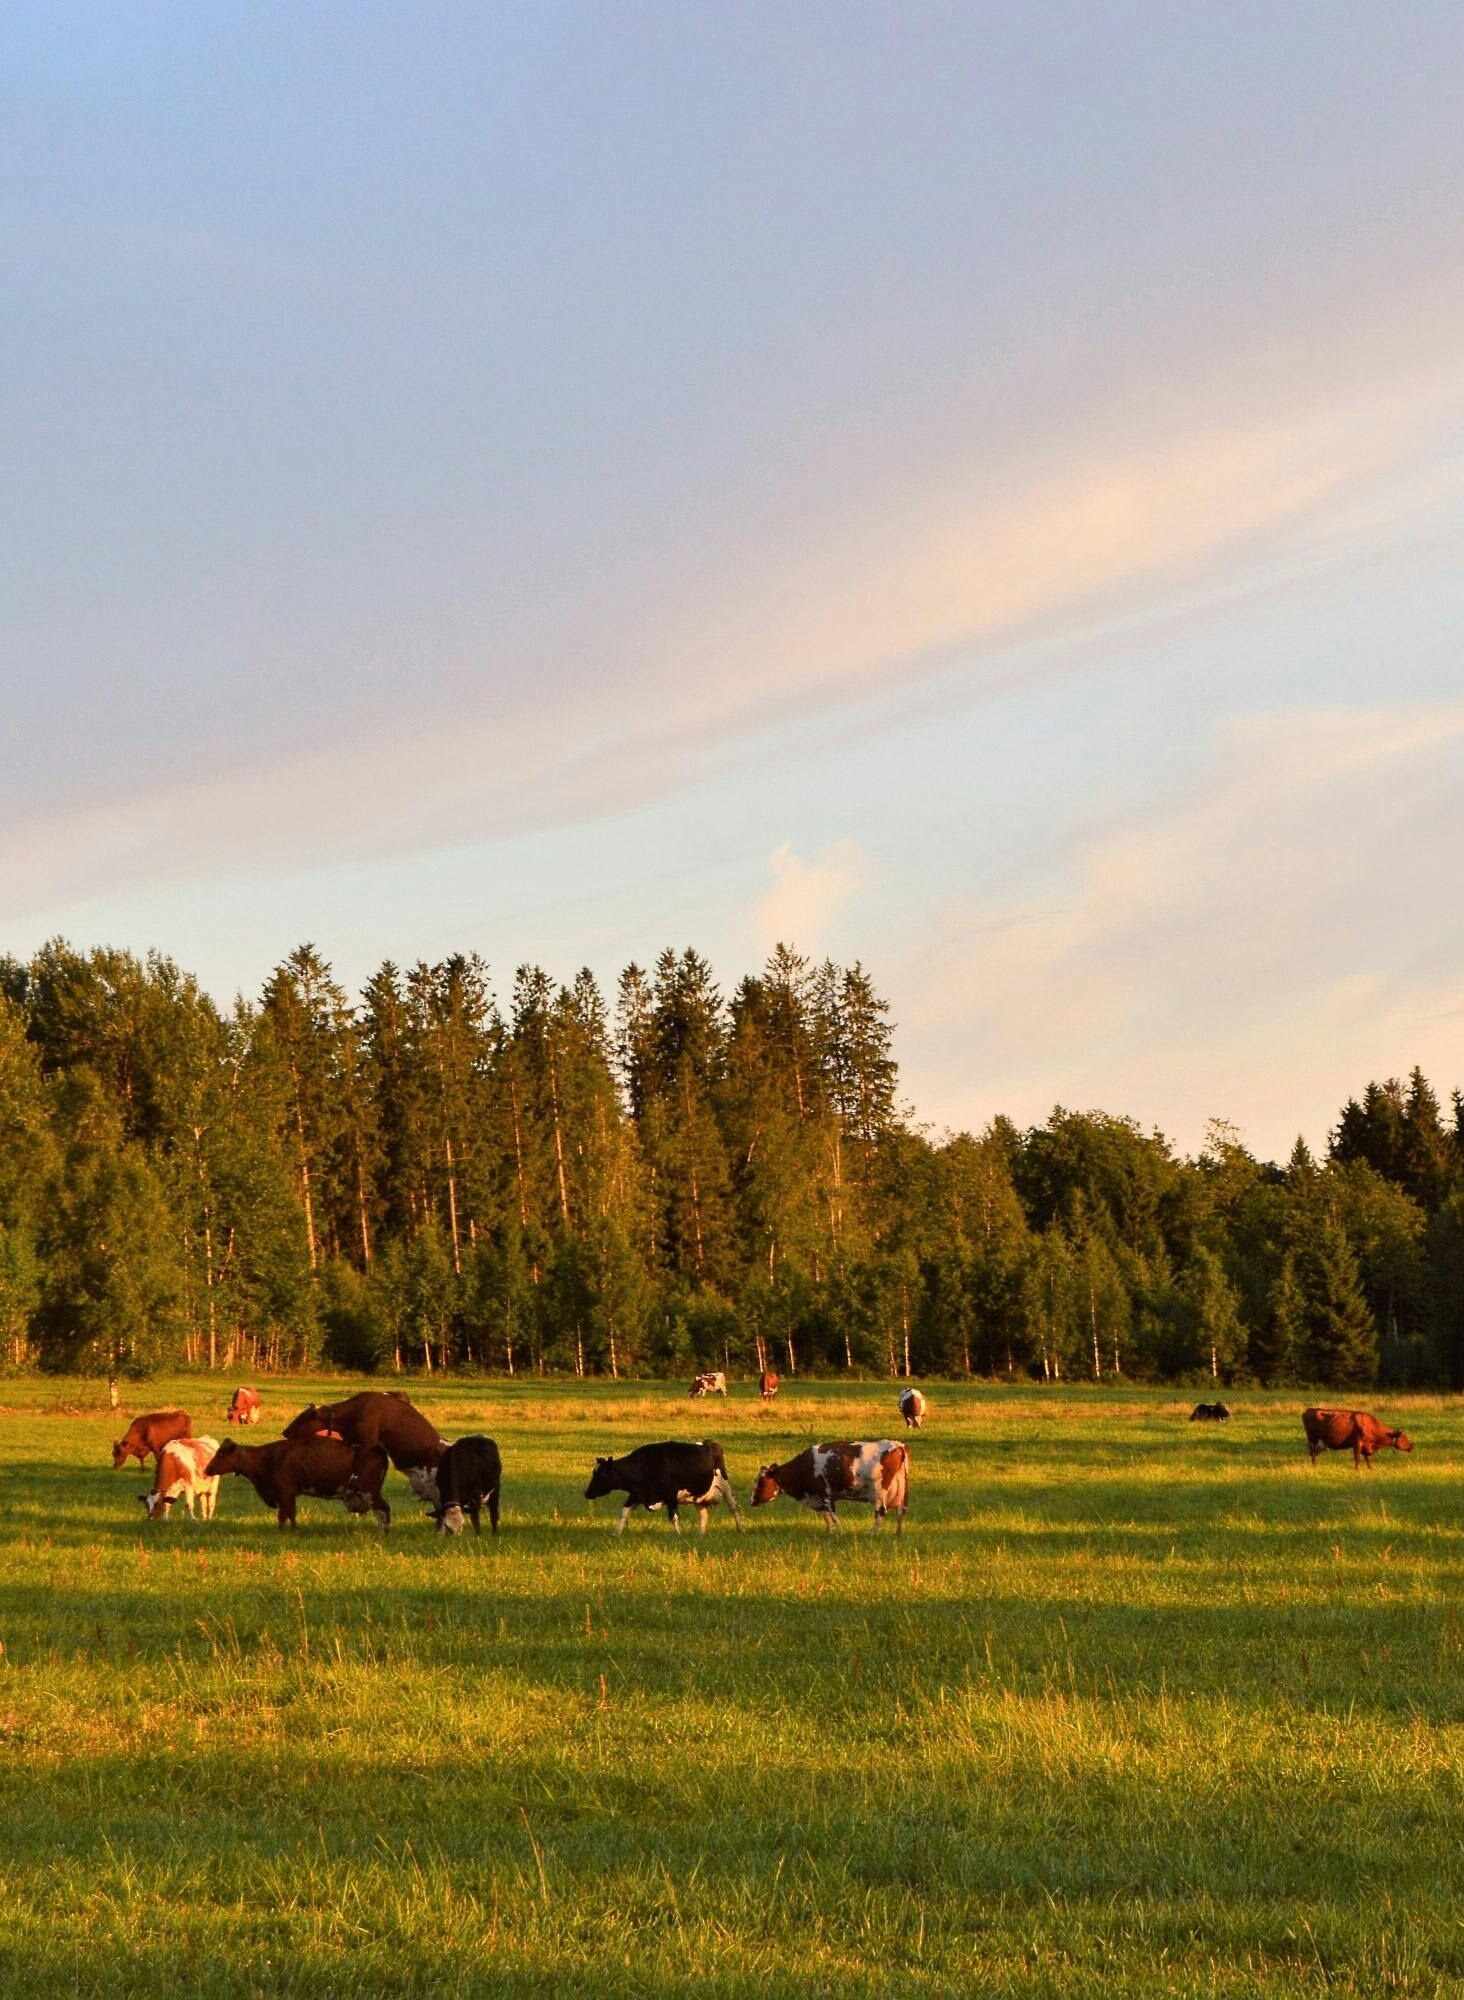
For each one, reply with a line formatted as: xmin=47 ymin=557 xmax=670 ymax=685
xmin=0 ymin=0 xmax=1464 ymax=1156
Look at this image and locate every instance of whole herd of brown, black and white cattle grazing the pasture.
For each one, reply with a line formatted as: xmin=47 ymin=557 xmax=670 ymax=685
xmin=100 ymin=1372 xmax=1414 ymax=1534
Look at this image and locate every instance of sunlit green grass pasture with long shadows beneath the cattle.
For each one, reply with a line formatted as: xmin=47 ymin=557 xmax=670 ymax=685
xmin=0 ymin=1380 xmax=1464 ymax=2000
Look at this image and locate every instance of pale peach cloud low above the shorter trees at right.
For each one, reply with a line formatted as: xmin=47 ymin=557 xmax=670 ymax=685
xmin=904 ymin=704 xmax=1464 ymax=1152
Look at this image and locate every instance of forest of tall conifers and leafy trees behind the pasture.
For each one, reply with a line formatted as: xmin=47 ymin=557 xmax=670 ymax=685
xmin=0 ymin=940 xmax=1464 ymax=1388
